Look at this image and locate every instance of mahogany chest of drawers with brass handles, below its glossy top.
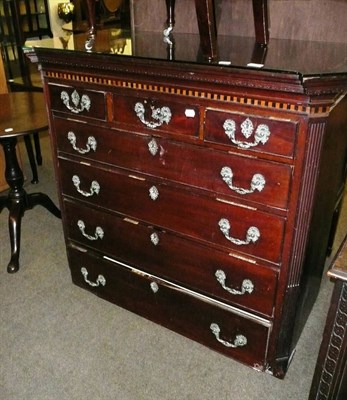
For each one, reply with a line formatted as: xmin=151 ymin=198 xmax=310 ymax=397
xmin=35 ymin=31 xmax=347 ymax=377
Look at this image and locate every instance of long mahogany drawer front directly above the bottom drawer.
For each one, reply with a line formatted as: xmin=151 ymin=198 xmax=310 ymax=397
xmin=64 ymin=201 xmax=277 ymax=316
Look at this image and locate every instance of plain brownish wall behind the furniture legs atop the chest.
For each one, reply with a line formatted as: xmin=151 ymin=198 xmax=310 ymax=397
xmin=131 ymin=0 xmax=347 ymax=42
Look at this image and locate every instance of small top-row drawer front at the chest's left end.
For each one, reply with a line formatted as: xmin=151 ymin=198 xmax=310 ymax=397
xmin=48 ymin=84 xmax=106 ymax=120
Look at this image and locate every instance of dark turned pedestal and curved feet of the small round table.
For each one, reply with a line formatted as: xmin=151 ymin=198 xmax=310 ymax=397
xmin=0 ymin=137 xmax=61 ymax=273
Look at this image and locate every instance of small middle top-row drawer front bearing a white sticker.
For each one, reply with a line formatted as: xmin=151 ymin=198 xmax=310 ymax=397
xmin=113 ymin=94 xmax=200 ymax=137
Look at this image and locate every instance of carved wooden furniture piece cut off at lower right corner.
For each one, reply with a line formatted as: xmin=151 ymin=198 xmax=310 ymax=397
xmin=309 ymin=236 xmax=347 ymax=400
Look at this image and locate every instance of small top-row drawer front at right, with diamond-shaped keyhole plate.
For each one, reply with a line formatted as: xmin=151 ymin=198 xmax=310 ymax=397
xmin=205 ymin=110 xmax=298 ymax=158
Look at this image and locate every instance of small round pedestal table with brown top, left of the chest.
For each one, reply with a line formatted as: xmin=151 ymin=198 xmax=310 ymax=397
xmin=0 ymin=92 xmax=61 ymax=273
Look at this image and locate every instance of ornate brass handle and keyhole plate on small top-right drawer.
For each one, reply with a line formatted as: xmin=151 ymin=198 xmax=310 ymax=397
xmin=223 ymin=118 xmax=271 ymax=149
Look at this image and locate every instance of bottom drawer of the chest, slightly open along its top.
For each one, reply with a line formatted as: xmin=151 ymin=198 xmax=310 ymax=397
xmin=68 ymin=245 xmax=271 ymax=370
